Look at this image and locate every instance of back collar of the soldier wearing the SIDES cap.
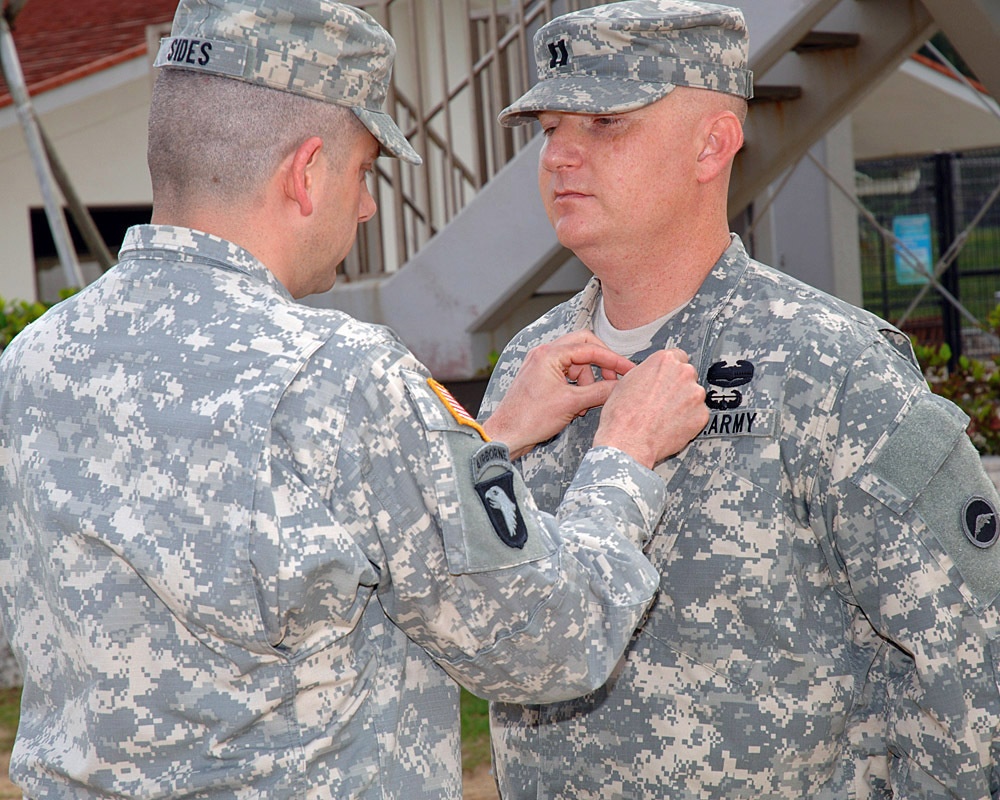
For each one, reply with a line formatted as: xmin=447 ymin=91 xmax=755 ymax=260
xmin=118 ymin=225 xmax=292 ymax=300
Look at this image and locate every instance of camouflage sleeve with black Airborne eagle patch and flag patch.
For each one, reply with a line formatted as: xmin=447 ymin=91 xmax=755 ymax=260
xmin=338 ymin=340 xmax=665 ymax=703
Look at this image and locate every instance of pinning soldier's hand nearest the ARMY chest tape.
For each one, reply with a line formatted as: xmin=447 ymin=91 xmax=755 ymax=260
xmin=594 ymin=349 xmax=708 ymax=469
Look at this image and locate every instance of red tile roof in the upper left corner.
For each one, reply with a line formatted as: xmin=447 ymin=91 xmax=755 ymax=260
xmin=0 ymin=0 xmax=177 ymax=108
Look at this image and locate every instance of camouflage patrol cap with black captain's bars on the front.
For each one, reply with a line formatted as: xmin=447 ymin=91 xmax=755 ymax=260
xmin=499 ymin=0 xmax=753 ymax=127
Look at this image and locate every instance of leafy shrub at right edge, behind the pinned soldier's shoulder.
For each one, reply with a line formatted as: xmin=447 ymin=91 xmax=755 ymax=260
xmin=913 ymin=306 xmax=1000 ymax=456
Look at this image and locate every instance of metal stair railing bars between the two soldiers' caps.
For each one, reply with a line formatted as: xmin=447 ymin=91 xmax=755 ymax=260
xmin=342 ymin=0 xmax=597 ymax=281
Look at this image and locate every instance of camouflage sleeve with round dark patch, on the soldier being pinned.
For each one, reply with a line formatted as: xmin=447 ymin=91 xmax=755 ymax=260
xmin=814 ymin=346 xmax=1000 ymax=798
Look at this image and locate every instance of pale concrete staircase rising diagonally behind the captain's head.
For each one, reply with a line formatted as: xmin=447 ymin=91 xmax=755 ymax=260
xmin=317 ymin=0 xmax=1000 ymax=381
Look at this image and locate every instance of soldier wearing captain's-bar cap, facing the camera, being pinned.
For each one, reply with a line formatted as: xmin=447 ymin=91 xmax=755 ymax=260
xmin=483 ymin=0 xmax=1000 ymax=800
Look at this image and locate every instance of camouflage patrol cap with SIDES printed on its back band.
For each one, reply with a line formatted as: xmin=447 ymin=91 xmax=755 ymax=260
xmin=155 ymin=0 xmax=421 ymax=164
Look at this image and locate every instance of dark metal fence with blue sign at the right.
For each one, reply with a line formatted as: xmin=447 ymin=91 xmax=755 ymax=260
xmin=856 ymin=150 xmax=1000 ymax=357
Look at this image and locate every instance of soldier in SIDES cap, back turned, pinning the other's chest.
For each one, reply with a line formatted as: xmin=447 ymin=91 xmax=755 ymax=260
xmin=0 ymin=0 xmax=707 ymax=800
